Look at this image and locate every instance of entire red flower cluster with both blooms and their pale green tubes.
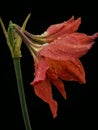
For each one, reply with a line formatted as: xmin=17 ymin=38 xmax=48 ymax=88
xmin=15 ymin=17 xmax=98 ymax=118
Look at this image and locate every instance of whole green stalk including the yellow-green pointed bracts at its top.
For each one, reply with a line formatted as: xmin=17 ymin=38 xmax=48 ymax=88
xmin=0 ymin=14 xmax=32 ymax=130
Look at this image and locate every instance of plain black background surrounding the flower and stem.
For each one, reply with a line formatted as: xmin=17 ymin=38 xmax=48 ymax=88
xmin=0 ymin=0 xmax=98 ymax=130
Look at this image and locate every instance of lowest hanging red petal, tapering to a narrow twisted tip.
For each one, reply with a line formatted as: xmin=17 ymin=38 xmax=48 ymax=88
xmin=32 ymin=78 xmax=57 ymax=118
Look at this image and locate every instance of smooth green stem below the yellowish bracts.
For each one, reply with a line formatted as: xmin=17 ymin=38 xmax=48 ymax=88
xmin=13 ymin=58 xmax=32 ymax=130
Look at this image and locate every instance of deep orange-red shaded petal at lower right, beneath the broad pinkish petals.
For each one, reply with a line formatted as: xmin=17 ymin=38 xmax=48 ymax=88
xmin=58 ymin=59 xmax=86 ymax=83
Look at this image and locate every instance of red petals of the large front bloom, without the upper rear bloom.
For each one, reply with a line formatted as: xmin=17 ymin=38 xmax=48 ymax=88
xmin=32 ymin=33 xmax=97 ymax=117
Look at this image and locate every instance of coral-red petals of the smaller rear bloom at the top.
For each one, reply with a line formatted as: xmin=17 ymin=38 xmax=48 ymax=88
xmin=46 ymin=17 xmax=81 ymax=42
